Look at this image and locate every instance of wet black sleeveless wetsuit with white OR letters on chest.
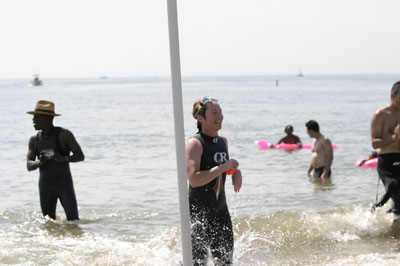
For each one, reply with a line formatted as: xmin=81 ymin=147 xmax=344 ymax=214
xmin=189 ymin=133 xmax=233 ymax=265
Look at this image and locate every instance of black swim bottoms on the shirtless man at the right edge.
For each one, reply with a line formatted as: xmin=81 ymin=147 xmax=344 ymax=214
xmin=375 ymin=153 xmax=400 ymax=214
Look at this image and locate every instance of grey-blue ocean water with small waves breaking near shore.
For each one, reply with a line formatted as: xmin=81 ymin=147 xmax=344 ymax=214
xmin=0 ymin=74 xmax=400 ymax=266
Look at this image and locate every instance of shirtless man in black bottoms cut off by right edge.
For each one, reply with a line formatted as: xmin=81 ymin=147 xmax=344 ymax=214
xmin=371 ymin=81 xmax=400 ymax=215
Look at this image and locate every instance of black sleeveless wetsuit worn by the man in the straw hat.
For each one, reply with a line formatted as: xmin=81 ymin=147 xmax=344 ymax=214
xmin=36 ymin=127 xmax=79 ymax=220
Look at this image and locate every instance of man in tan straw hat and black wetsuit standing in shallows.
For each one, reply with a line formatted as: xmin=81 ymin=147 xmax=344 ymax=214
xmin=26 ymin=100 xmax=85 ymax=221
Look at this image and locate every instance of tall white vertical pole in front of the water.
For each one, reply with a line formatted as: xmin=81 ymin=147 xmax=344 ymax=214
xmin=168 ymin=0 xmax=192 ymax=266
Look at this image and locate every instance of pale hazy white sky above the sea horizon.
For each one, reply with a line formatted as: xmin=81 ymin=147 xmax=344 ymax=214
xmin=0 ymin=0 xmax=400 ymax=79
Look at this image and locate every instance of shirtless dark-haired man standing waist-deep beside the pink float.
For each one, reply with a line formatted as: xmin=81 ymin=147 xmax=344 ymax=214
xmin=306 ymin=120 xmax=333 ymax=178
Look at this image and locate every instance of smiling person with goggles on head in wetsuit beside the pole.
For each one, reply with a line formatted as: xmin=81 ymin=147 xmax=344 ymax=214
xmin=186 ymin=97 xmax=242 ymax=265
